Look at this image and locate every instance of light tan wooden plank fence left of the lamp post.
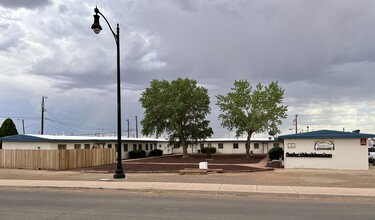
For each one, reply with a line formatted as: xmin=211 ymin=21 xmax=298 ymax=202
xmin=0 ymin=148 xmax=116 ymax=170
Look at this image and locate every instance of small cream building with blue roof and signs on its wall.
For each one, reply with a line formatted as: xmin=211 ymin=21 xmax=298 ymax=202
xmin=279 ymin=130 xmax=375 ymax=170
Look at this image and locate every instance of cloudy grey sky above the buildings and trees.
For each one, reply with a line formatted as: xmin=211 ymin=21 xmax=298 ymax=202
xmin=0 ymin=0 xmax=375 ymax=137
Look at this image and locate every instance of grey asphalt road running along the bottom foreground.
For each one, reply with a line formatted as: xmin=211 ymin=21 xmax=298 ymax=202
xmin=0 ymin=189 xmax=375 ymax=220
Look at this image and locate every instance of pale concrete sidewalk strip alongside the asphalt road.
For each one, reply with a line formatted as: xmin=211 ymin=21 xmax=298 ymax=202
xmin=0 ymin=179 xmax=375 ymax=197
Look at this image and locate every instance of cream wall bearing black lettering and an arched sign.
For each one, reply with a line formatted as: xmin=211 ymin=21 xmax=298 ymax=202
xmin=284 ymin=139 xmax=369 ymax=170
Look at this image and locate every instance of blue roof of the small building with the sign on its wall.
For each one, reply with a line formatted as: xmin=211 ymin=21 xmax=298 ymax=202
xmin=278 ymin=130 xmax=375 ymax=139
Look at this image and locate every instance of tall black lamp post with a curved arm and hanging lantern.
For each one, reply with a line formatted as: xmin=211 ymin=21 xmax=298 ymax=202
xmin=91 ymin=7 xmax=125 ymax=179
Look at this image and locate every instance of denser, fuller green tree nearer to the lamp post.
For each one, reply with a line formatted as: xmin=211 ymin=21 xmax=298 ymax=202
xmin=139 ymin=78 xmax=213 ymax=157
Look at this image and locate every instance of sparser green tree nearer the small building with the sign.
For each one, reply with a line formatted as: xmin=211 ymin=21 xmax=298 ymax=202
xmin=216 ymin=80 xmax=288 ymax=157
